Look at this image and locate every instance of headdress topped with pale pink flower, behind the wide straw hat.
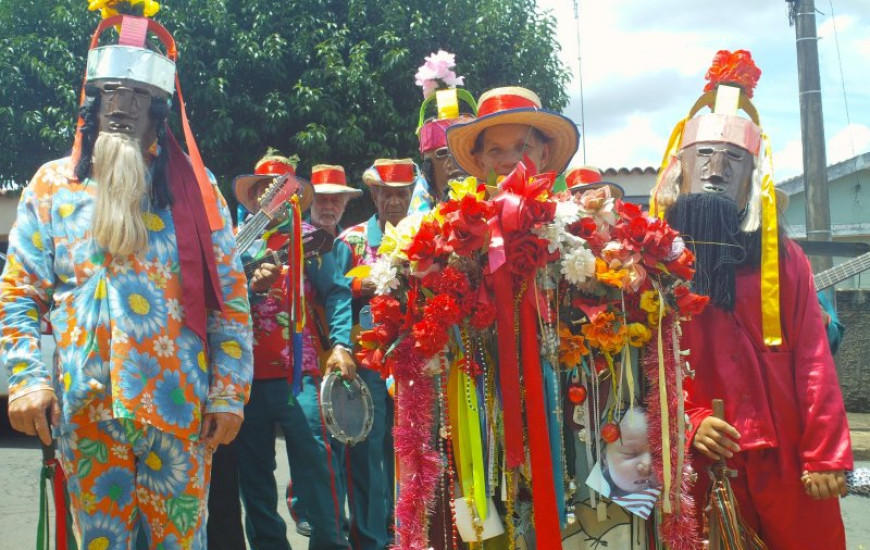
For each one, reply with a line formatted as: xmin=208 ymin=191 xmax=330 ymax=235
xmin=414 ymin=50 xmax=477 ymax=153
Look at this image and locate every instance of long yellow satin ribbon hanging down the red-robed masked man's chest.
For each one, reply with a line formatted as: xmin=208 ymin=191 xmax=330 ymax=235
xmin=761 ymin=134 xmax=782 ymax=346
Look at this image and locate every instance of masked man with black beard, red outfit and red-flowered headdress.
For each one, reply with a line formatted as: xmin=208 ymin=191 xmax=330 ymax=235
xmin=651 ymin=51 xmax=852 ymax=550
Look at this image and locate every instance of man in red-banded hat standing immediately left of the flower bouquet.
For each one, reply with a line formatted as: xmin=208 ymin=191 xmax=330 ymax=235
xmin=333 ymin=159 xmax=419 ymax=550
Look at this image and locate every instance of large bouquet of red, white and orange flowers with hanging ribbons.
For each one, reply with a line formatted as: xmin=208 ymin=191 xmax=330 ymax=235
xmin=358 ymin=159 xmax=706 ymax=550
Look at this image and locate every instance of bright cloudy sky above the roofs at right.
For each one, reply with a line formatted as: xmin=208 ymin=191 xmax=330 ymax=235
xmin=537 ymin=0 xmax=870 ymax=181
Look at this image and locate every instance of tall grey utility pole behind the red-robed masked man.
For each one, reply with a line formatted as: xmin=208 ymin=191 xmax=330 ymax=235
xmin=786 ymin=0 xmax=833 ymax=273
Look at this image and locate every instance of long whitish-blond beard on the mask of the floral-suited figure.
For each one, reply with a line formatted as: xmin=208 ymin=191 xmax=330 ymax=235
xmin=92 ymin=132 xmax=148 ymax=256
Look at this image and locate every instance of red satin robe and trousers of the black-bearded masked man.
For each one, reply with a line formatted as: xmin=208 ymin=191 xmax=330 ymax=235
xmin=682 ymin=240 xmax=852 ymax=550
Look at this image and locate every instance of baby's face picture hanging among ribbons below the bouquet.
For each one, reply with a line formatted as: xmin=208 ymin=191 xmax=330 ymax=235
xmin=604 ymin=413 xmax=653 ymax=493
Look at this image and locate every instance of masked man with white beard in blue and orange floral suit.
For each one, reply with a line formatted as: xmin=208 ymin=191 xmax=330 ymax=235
xmin=0 ymin=2 xmax=251 ymax=549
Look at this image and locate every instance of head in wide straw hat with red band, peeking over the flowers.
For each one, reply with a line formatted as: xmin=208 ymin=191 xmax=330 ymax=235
xmin=447 ymin=86 xmax=580 ymax=181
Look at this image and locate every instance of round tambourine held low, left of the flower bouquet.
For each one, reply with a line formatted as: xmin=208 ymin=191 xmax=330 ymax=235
xmin=320 ymin=372 xmax=375 ymax=445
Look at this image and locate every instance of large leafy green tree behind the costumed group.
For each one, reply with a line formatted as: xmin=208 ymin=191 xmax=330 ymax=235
xmin=0 ymin=0 xmax=568 ymax=222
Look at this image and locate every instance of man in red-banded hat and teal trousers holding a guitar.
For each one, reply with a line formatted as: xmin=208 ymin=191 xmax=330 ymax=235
xmin=233 ymin=155 xmax=356 ymax=550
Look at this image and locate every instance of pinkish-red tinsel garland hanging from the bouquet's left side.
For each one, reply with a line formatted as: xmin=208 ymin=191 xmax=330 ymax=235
xmin=391 ymin=338 xmax=441 ymax=550
